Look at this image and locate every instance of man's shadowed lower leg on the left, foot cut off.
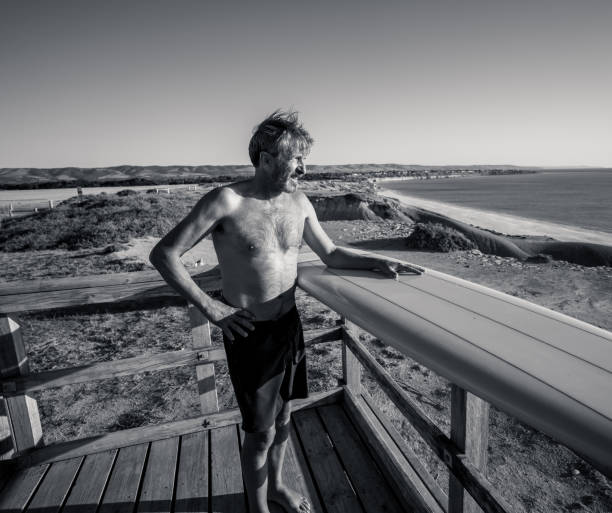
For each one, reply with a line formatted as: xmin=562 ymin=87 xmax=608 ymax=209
xmin=240 ymin=427 xmax=274 ymax=513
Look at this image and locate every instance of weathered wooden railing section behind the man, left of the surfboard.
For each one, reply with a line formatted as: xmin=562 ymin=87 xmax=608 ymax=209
xmin=0 ymin=262 xmax=341 ymax=454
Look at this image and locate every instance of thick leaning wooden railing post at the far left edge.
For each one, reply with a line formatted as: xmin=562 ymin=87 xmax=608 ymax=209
xmin=0 ymin=316 xmax=42 ymax=460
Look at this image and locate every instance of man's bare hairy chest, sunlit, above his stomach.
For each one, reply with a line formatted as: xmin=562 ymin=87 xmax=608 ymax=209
xmin=215 ymin=202 xmax=304 ymax=255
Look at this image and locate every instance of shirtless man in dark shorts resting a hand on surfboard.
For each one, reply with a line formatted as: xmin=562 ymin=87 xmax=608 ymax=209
xmin=150 ymin=111 xmax=418 ymax=513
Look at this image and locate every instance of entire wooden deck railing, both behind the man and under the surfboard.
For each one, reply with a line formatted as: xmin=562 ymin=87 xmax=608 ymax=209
xmin=0 ymin=260 xmax=608 ymax=513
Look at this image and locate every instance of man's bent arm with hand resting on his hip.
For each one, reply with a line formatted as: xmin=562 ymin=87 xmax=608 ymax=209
xmin=149 ymin=187 xmax=252 ymax=340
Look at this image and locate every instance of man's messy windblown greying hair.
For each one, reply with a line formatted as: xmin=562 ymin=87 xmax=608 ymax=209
xmin=249 ymin=109 xmax=314 ymax=167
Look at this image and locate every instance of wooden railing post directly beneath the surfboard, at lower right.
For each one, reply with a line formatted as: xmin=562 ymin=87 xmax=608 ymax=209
xmin=448 ymin=383 xmax=489 ymax=513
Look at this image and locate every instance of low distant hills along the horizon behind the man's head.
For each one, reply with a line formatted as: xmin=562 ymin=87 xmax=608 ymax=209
xmin=0 ymin=164 xmax=527 ymax=187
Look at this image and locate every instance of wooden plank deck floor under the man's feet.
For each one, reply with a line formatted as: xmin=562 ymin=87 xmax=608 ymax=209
xmin=0 ymin=403 xmax=411 ymax=513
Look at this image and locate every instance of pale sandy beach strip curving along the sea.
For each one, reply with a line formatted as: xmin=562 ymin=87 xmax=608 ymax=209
xmin=375 ymin=187 xmax=612 ymax=246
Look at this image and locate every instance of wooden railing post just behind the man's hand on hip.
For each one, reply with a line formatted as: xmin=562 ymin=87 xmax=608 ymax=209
xmin=188 ymin=305 xmax=219 ymax=415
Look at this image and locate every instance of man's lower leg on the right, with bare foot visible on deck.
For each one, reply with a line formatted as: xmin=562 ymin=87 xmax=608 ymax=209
xmin=268 ymin=401 xmax=310 ymax=513
